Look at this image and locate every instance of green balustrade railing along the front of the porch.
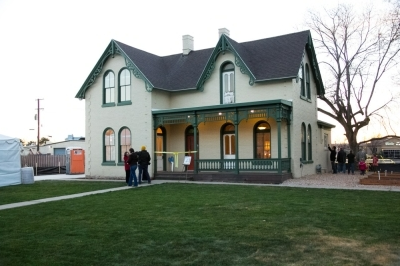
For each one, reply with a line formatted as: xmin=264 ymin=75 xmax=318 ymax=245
xmin=197 ymin=158 xmax=290 ymax=173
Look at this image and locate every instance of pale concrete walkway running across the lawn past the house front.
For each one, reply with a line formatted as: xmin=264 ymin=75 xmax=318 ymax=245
xmin=0 ymin=174 xmax=400 ymax=210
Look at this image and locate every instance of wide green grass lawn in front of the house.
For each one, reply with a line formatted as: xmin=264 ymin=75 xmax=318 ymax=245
xmin=0 ymin=181 xmax=400 ymax=265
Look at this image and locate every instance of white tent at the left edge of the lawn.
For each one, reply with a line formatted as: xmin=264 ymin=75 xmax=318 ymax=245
xmin=0 ymin=134 xmax=22 ymax=187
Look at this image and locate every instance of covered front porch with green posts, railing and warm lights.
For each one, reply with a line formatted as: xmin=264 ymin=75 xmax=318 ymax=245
xmin=152 ymin=100 xmax=292 ymax=184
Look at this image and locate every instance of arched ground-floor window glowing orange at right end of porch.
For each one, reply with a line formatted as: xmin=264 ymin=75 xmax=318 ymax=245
xmin=254 ymin=121 xmax=271 ymax=159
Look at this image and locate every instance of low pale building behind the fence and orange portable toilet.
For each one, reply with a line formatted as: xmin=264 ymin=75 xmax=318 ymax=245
xmin=22 ymin=135 xmax=86 ymax=155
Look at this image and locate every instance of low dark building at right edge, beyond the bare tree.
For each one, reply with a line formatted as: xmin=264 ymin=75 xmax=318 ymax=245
xmin=360 ymin=137 xmax=400 ymax=159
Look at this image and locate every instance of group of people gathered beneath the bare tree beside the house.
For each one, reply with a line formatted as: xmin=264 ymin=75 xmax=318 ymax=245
xmin=328 ymin=144 xmax=378 ymax=175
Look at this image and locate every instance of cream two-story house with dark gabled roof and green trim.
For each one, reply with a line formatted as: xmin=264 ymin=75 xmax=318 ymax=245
xmin=76 ymin=29 xmax=334 ymax=182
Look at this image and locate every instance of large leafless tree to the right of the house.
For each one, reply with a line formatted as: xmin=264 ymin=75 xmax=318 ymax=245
xmin=306 ymin=0 xmax=400 ymax=152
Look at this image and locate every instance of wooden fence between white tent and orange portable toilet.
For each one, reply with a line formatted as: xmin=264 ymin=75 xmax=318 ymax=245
xmin=21 ymin=154 xmax=67 ymax=167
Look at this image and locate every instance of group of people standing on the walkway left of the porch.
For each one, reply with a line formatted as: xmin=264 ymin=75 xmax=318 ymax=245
xmin=124 ymin=146 xmax=151 ymax=187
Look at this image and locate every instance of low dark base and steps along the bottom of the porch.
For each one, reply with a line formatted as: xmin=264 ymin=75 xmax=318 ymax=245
xmin=154 ymin=171 xmax=292 ymax=184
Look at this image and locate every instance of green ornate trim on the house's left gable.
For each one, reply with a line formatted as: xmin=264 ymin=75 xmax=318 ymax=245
xmin=75 ymin=40 xmax=154 ymax=99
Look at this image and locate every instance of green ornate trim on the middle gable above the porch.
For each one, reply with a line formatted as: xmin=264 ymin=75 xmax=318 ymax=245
xmin=196 ymin=34 xmax=256 ymax=91
